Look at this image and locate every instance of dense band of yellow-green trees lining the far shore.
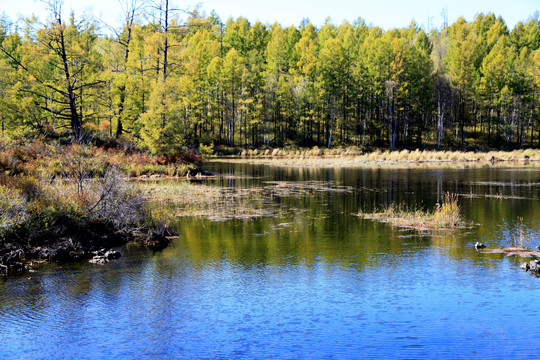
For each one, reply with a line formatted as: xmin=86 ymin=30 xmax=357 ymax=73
xmin=0 ymin=0 xmax=540 ymax=152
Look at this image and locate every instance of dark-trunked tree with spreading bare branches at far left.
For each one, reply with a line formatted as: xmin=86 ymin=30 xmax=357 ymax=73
xmin=1 ymin=1 xmax=103 ymax=141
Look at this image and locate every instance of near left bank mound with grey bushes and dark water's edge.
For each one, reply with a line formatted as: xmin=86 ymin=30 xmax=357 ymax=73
xmin=0 ymin=169 xmax=174 ymax=276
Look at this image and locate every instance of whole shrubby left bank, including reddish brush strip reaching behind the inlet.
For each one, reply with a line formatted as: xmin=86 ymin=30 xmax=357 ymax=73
xmin=0 ymin=141 xmax=195 ymax=275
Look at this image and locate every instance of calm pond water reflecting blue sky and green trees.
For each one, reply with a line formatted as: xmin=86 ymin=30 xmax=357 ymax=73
xmin=0 ymin=162 xmax=540 ymax=359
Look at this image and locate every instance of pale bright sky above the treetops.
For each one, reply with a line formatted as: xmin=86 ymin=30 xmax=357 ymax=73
xmin=0 ymin=0 xmax=540 ymax=30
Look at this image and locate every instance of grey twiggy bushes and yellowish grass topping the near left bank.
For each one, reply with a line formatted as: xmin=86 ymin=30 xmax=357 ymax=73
xmin=0 ymin=169 xmax=149 ymax=245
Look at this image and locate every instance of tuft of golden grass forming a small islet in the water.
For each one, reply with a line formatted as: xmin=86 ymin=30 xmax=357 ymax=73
xmin=358 ymin=193 xmax=465 ymax=230
